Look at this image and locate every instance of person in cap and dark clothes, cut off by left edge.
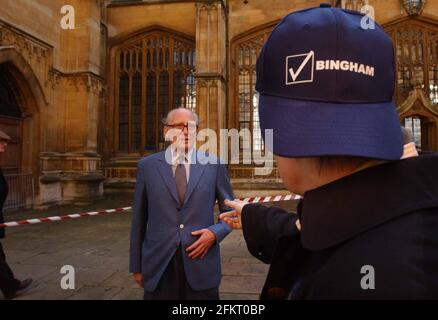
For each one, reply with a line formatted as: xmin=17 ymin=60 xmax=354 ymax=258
xmin=0 ymin=130 xmax=32 ymax=300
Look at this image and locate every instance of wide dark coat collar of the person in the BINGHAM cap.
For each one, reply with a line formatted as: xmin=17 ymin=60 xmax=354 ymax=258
xmin=298 ymin=154 xmax=438 ymax=251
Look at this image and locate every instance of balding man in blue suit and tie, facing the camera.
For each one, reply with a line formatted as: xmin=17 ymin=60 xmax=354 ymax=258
xmin=130 ymin=108 xmax=234 ymax=300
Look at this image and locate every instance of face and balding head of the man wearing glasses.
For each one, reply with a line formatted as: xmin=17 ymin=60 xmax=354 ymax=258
xmin=164 ymin=109 xmax=196 ymax=151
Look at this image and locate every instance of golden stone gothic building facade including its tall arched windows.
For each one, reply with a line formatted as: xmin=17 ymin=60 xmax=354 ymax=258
xmin=0 ymin=0 xmax=438 ymax=205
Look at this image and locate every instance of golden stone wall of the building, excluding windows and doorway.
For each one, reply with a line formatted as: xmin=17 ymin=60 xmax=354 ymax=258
xmin=0 ymin=0 xmax=438 ymax=205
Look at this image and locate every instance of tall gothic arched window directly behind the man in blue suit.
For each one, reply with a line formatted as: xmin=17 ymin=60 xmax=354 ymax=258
xmin=115 ymin=31 xmax=196 ymax=153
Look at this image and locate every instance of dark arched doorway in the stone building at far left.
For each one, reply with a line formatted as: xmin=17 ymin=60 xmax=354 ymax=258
xmin=0 ymin=46 xmax=47 ymax=208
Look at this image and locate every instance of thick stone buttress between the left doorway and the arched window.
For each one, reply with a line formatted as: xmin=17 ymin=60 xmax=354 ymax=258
xmin=40 ymin=0 xmax=106 ymax=205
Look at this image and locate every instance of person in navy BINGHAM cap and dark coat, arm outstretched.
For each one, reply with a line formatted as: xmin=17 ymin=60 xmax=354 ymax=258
xmin=220 ymin=5 xmax=438 ymax=299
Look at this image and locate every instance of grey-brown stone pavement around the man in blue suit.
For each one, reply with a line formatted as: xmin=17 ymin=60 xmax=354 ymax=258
xmin=0 ymin=194 xmax=294 ymax=300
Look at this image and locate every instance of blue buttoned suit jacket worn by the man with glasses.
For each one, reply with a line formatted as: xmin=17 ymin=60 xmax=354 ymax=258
xmin=129 ymin=151 xmax=234 ymax=292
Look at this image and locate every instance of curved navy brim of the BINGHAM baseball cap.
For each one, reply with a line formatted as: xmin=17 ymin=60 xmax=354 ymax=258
xmin=259 ymin=94 xmax=403 ymax=160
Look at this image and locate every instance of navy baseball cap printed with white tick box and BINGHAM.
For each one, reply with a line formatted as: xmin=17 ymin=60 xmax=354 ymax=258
xmin=256 ymin=4 xmax=403 ymax=160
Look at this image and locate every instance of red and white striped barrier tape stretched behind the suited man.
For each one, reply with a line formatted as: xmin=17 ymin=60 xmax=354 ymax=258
xmin=0 ymin=194 xmax=301 ymax=229
